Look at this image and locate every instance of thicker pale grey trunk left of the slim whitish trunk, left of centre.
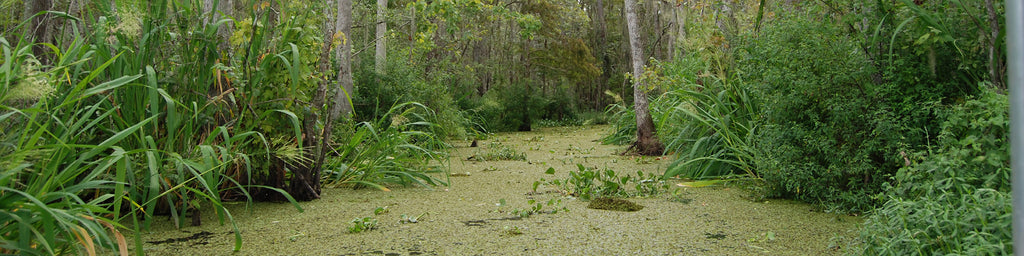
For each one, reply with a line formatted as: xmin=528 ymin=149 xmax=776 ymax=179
xmin=330 ymin=0 xmax=353 ymax=121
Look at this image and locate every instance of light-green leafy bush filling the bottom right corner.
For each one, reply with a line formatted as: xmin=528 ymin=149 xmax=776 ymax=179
xmin=860 ymin=91 xmax=1013 ymax=255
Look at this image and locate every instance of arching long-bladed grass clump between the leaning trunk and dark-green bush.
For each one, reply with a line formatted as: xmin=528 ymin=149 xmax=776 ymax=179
xmin=659 ymin=78 xmax=759 ymax=179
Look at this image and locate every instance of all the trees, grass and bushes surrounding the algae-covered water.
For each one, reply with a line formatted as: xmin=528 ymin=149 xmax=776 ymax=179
xmin=0 ymin=0 xmax=1013 ymax=255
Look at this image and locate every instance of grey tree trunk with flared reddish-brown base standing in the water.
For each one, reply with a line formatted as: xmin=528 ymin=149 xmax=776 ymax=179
xmin=626 ymin=0 xmax=665 ymax=156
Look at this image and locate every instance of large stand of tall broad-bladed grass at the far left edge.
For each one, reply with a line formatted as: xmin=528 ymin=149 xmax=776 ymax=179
xmin=0 ymin=1 xmax=311 ymax=255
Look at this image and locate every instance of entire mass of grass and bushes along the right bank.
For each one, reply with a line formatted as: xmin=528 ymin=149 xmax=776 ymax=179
xmin=604 ymin=0 xmax=1012 ymax=251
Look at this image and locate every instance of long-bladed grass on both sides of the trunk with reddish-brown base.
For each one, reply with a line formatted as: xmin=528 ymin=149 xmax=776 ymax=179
xmin=602 ymin=54 xmax=761 ymax=179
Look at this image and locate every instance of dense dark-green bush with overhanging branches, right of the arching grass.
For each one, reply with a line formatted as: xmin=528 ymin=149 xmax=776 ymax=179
xmin=738 ymin=2 xmax=999 ymax=211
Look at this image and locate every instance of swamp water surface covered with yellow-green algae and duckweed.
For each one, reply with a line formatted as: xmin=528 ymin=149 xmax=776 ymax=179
xmin=132 ymin=126 xmax=861 ymax=255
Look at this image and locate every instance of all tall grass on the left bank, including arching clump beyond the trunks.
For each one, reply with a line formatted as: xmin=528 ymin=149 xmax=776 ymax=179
xmin=0 ymin=0 xmax=458 ymax=252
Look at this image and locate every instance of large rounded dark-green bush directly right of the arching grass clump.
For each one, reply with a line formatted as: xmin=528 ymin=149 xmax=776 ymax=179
xmin=740 ymin=9 xmax=900 ymax=211
